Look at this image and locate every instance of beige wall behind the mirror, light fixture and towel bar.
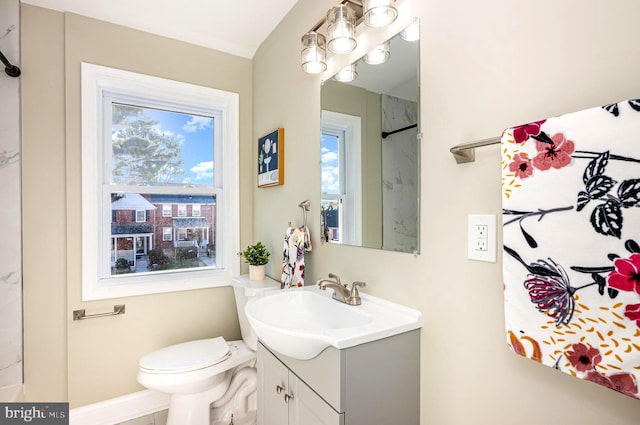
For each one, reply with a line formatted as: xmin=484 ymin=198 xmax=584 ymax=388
xmin=253 ymin=0 xmax=640 ymax=425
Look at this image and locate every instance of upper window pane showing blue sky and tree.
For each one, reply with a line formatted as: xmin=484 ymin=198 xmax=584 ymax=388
xmin=111 ymin=102 xmax=214 ymax=186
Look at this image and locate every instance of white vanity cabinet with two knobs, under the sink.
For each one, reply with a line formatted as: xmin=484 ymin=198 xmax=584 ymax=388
xmin=257 ymin=329 xmax=420 ymax=425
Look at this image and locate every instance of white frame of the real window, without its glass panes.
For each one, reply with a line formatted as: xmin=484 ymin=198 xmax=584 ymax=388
xmin=81 ymin=63 xmax=240 ymax=301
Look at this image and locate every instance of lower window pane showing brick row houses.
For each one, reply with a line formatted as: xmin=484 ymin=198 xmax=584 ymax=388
xmin=110 ymin=193 xmax=216 ymax=275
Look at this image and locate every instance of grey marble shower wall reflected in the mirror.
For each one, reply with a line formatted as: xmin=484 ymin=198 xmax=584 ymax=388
xmin=382 ymin=95 xmax=420 ymax=252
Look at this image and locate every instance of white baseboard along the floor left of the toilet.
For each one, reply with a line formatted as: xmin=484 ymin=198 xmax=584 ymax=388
xmin=69 ymin=390 xmax=169 ymax=425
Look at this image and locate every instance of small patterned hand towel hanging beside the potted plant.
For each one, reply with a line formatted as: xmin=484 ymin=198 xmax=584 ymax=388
xmin=280 ymin=226 xmax=311 ymax=289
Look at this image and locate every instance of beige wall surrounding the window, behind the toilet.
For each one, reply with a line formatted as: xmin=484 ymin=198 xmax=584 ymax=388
xmin=21 ymin=5 xmax=254 ymax=407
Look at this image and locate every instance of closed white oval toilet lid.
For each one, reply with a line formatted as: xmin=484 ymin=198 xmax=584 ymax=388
xmin=140 ymin=336 xmax=231 ymax=372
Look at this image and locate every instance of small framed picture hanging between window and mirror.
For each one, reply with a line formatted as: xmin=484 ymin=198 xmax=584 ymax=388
xmin=258 ymin=128 xmax=284 ymax=187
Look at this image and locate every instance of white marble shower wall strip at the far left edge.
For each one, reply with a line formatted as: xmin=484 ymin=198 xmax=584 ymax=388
xmin=0 ymin=0 xmax=22 ymax=388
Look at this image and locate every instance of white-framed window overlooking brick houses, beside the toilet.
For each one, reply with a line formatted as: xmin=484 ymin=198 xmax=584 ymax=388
xmin=82 ymin=63 xmax=239 ymax=300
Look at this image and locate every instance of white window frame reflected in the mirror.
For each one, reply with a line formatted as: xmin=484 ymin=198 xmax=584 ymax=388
xmin=321 ymin=110 xmax=362 ymax=245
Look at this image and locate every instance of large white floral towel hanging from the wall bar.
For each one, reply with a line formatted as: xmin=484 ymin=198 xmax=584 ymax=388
xmin=502 ymin=99 xmax=640 ymax=398
